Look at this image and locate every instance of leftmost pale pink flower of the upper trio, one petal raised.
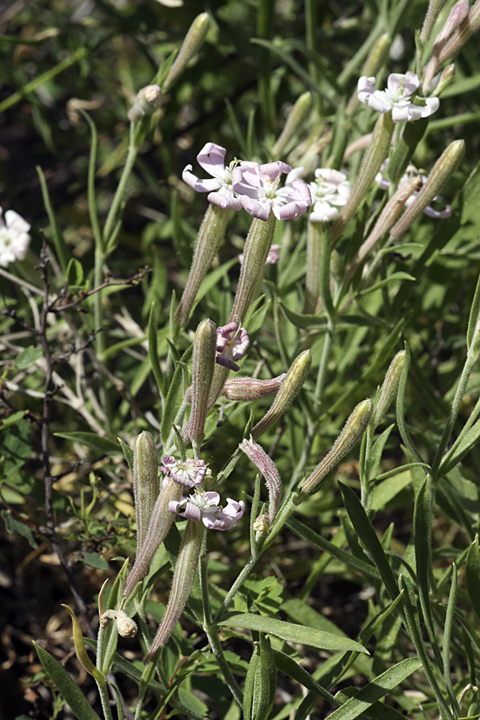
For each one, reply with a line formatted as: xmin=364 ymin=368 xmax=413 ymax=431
xmin=182 ymin=143 xmax=242 ymax=210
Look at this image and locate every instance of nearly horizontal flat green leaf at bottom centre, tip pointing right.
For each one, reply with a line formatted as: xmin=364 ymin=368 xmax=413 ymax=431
xmin=220 ymin=613 xmax=368 ymax=654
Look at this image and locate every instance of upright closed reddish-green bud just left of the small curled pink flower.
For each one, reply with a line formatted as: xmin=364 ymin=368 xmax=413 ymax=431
xmin=183 ymin=320 xmax=217 ymax=441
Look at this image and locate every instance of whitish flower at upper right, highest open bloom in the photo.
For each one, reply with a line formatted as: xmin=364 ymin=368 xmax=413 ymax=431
xmin=357 ymin=72 xmax=440 ymax=122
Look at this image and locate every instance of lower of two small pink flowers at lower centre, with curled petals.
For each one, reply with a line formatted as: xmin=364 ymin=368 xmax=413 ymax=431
xmin=168 ymin=491 xmax=245 ymax=531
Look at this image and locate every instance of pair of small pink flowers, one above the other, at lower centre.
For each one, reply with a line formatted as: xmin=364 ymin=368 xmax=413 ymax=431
xmin=161 ymin=455 xmax=245 ymax=531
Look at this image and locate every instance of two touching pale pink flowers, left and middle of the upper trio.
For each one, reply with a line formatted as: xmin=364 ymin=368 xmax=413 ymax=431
xmin=182 ymin=143 xmax=312 ymax=221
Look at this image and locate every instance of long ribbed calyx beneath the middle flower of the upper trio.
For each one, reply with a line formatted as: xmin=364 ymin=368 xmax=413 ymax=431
xmin=229 ymin=213 xmax=276 ymax=327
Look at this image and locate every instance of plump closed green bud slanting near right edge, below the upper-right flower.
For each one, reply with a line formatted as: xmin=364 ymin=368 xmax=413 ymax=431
xmin=390 ymin=140 xmax=465 ymax=240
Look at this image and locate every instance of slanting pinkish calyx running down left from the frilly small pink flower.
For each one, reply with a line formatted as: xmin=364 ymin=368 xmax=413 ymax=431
xmin=123 ymin=479 xmax=182 ymax=597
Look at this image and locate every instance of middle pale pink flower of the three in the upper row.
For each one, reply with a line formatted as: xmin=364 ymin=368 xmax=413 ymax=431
xmin=232 ymin=160 xmax=312 ymax=221
